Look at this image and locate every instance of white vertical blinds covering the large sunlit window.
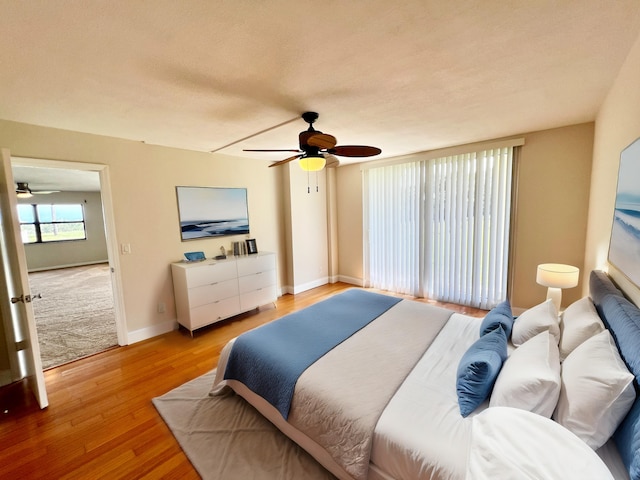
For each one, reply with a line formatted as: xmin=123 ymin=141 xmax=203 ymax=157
xmin=365 ymin=147 xmax=513 ymax=309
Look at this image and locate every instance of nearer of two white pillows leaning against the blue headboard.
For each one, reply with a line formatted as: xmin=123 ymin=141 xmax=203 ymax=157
xmin=553 ymin=330 xmax=636 ymax=450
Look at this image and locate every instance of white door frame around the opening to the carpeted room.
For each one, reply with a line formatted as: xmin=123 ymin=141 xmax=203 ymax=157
xmin=11 ymin=156 xmax=129 ymax=345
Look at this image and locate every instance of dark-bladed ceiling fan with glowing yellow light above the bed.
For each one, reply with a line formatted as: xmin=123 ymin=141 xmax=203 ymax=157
xmin=244 ymin=112 xmax=382 ymax=171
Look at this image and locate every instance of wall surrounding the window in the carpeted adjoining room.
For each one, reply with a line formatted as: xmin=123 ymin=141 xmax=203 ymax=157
xmin=18 ymin=192 xmax=108 ymax=272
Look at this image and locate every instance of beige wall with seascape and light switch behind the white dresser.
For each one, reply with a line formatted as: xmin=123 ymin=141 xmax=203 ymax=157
xmin=0 ymin=121 xmax=285 ymax=338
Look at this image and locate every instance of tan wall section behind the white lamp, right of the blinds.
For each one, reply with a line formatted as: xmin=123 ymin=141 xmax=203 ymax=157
xmin=510 ymin=123 xmax=594 ymax=308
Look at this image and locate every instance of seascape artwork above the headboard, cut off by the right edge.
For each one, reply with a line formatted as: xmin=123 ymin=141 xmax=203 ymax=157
xmin=609 ymin=139 xmax=640 ymax=286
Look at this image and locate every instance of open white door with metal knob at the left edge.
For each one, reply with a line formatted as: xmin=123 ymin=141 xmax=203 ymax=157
xmin=0 ymin=148 xmax=49 ymax=408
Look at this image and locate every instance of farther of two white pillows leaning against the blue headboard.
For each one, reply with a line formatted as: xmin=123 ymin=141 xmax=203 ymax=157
xmin=560 ymin=297 xmax=604 ymax=361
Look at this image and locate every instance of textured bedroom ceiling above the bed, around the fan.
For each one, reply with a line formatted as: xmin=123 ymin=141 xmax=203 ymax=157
xmin=0 ymin=0 xmax=640 ymax=186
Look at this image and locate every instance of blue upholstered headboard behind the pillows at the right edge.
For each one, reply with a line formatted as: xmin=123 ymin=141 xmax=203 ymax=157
xmin=589 ymin=270 xmax=640 ymax=480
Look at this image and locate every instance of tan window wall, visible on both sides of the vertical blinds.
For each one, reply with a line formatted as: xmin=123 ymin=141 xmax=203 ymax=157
xmin=337 ymin=123 xmax=594 ymax=308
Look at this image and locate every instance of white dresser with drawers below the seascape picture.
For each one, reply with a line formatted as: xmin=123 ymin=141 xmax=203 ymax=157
xmin=171 ymin=252 xmax=278 ymax=332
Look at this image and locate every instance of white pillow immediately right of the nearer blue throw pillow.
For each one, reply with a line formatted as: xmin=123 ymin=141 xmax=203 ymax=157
xmin=489 ymin=331 xmax=560 ymax=418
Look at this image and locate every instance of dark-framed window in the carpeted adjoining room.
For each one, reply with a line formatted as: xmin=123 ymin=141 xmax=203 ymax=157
xmin=18 ymin=203 xmax=87 ymax=243
